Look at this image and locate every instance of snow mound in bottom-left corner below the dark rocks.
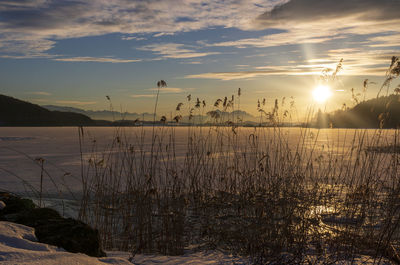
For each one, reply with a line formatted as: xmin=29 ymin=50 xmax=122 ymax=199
xmin=0 ymin=222 xmax=132 ymax=265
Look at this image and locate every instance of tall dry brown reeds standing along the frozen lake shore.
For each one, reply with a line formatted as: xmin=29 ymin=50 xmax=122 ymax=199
xmin=72 ymin=71 xmax=400 ymax=264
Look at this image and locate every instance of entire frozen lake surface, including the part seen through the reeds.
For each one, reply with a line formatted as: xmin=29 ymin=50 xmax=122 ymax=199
xmin=0 ymin=127 xmax=400 ymax=258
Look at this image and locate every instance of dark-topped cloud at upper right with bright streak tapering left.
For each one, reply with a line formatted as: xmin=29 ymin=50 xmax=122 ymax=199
xmin=211 ymin=0 xmax=400 ymax=48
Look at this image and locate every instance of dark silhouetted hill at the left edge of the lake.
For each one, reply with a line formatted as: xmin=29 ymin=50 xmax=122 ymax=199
xmin=0 ymin=95 xmax=96 ymax=126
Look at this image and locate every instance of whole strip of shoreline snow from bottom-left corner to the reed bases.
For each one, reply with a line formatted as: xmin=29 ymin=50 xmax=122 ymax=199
xmin=0 ymin=221 xmax=249 ymax=265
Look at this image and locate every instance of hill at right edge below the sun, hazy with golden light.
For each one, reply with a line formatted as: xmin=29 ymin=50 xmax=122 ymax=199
xmin=315 ymin=95 xmax=400 ymax=128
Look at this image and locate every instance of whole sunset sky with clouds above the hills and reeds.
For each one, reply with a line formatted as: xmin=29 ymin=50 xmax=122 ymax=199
xmin=0 ymin=0 xmax=400 ymax=117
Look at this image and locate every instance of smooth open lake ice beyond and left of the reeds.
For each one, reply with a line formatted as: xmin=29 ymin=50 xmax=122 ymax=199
xmin=0 ymin=127 xmax=396 ymax=192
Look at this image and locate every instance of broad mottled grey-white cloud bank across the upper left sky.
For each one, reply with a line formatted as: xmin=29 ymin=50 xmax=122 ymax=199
xmin=0 ymin=0 xmax=272 ymax=56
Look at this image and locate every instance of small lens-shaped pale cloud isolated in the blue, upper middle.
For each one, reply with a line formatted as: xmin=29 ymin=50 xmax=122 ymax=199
xmin=138 ymin=43 xmax=218 ymax=59
